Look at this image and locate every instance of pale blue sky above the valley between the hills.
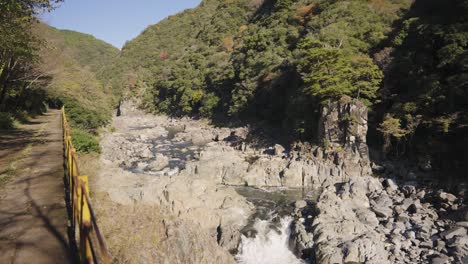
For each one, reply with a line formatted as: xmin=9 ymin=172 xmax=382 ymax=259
xmin=42 ymin=0 xmax=201 ymax=48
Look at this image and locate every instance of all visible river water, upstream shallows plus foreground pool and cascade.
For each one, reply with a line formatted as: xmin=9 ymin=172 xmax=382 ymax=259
xmin=117 ymin=122 xmax=317 ymax=264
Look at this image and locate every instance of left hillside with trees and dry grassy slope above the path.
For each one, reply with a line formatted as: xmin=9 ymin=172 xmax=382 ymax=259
xmin=0 ymin=0 xmax=119 ymax=152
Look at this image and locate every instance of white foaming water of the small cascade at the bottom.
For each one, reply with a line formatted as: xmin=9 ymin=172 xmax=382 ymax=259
xmin=236 ymin=216 xmax=305 ymax=264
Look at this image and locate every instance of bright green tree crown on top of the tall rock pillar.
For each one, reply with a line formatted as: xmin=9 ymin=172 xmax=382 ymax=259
xmin=298 ymin=38 xmax=383 ymax=104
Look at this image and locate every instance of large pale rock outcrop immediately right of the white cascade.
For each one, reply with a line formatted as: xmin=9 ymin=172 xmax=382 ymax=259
xmin=312 ymin=177 xmax=390 ymax=264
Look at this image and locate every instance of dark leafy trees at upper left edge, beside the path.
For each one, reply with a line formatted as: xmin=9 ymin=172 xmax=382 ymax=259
xmin=0 ymin=0 xmax=61 ymax=112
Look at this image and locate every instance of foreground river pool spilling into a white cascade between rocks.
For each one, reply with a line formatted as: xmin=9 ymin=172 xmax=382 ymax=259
xmin=235 ymin=187 xmax=316 ymax=264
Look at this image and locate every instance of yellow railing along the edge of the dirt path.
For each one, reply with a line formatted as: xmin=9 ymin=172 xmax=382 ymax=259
xmin=62 ymin=108 xmax=110 ymax=264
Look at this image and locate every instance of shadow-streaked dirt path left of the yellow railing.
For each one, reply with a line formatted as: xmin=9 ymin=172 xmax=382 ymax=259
xmin=0 ymin=110 xmax=72 ymax=264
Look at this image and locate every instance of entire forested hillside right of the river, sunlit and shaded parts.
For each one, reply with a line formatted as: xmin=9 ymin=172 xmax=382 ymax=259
xmin=114 ymin=0 xmax=468 ymax=177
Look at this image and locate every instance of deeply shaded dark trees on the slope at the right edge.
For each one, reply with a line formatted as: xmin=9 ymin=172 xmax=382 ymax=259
xmin=379 ymin=0 xmax=468 ymax=173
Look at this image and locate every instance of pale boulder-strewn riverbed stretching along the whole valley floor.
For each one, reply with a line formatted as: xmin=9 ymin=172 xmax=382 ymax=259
xmin=96 ymin=100 xmax=468 ymax=263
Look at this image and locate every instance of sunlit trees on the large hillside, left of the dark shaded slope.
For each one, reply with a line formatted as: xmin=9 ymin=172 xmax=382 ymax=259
xmin=117 ymin=0 xmax=410 ymax=137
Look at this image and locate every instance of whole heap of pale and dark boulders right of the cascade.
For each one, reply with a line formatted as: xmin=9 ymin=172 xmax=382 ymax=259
xmin=292 ymin=177 xmax=468 ymax=264
